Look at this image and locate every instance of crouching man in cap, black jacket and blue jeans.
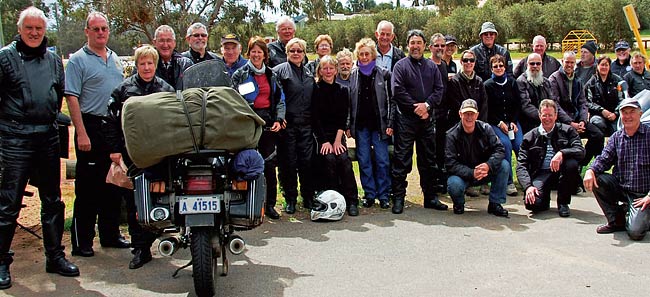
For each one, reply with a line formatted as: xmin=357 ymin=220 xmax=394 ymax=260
xmin=445 ymin=99 xmax=510 ymax=217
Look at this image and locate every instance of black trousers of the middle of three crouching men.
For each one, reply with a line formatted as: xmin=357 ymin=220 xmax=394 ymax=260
xmin=524 ymin=158 xmax=580 ymax=211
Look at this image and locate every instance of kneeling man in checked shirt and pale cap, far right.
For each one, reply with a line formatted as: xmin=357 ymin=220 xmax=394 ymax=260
xmin=583 ymin=98 xmax=650 ymax=240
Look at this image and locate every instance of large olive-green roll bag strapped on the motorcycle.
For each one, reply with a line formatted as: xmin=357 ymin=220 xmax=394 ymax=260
xmin=122 ymin=87 xmax=264 ymax=168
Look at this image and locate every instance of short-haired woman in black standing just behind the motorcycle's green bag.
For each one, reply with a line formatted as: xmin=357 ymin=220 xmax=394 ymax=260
xmin=103 ymin=45 xmax=174 ymax=269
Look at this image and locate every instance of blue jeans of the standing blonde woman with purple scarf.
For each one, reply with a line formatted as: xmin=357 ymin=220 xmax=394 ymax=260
xmin=355 ymin=128 xmax=390 ymax=201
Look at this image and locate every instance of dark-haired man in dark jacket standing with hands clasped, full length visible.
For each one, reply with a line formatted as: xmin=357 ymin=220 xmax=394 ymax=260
xmin=391 ymin=30 xmax=447 ymax=214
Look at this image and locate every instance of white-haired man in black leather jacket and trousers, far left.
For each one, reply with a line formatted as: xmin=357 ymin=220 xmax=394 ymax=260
xmin=0 ymin=6 xmax=79 ymax=290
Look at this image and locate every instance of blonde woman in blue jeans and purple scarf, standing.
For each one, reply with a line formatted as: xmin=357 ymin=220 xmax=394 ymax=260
xmin=348 ymin=38 xmax=394 ymax=209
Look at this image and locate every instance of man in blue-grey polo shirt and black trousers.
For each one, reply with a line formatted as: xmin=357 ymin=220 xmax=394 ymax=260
xmin=65 ymin=12 xmax=130 ymax=257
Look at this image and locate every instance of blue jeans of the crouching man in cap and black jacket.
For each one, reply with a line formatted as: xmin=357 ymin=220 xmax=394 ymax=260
xmin=447 ymin=160 xmax=512 ymax=205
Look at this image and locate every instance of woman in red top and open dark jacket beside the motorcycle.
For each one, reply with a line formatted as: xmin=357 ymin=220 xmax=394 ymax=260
xmin=232 ymin=36 xmax=286 ymax=219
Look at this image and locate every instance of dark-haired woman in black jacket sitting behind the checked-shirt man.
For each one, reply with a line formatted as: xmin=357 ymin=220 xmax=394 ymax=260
xmin=585 ymin=55 xmax=623 ymax=136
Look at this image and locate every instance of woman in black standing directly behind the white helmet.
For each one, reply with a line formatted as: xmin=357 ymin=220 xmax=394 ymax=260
xmin=312 ymin=56 xmax=359 ymax=216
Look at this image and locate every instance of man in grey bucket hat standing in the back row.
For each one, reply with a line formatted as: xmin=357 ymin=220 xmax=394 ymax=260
xmin=470 ymin=22 xmax=514 ymax=81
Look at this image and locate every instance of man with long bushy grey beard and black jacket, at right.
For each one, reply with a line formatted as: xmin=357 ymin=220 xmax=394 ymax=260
xmin=517 ymin=53 xmax=557 ymax=134
